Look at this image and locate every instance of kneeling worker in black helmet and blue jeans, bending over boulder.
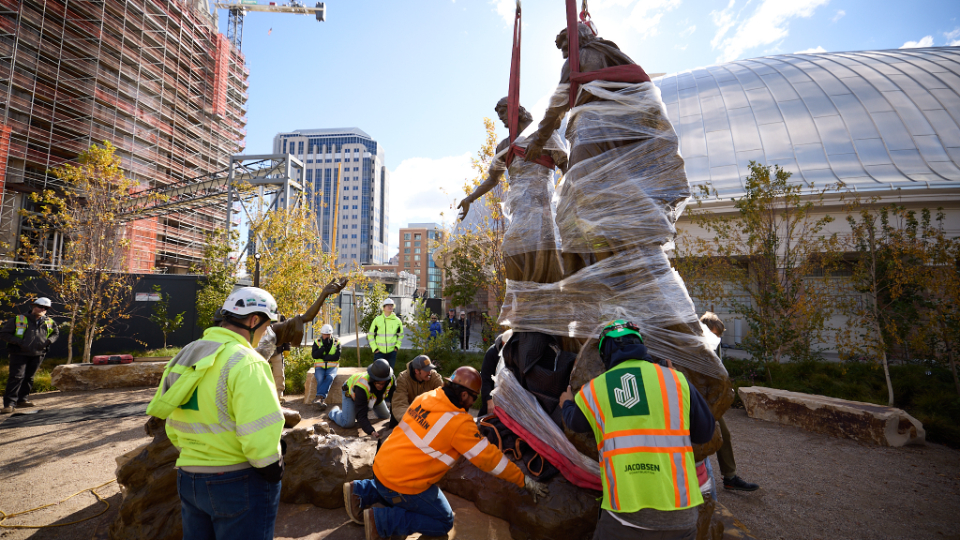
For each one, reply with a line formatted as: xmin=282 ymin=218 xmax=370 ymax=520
xmin=328 ymin=358 xmax=393 ymax=439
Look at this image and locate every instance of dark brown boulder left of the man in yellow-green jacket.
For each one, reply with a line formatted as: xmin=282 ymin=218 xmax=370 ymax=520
xmin=110 ymin=416 xmax=183 ymax=540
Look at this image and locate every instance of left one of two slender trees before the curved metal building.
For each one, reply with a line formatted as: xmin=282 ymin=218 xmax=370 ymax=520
xmin=676 ymin=162 xmax=842 ymax=381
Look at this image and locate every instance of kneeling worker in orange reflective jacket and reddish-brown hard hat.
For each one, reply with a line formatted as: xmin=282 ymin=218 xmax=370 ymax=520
xmin=343 ymin=366 xmax=547 ymax=540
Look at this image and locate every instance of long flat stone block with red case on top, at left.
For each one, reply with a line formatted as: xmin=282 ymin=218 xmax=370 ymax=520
xmin=51 ymin=362 xmax=167 ymax=392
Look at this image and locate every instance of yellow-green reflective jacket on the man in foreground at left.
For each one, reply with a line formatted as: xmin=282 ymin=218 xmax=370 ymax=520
xmin=147 ymin=327 xmax=283 ymax=468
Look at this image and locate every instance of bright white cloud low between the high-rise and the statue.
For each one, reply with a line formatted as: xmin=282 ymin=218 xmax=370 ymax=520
xmin=388 ymin=152 xmax=475 ymax=252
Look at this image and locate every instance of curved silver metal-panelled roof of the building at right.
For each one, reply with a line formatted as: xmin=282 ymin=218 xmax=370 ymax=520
xmin=654 ymin=47 xmax=960 ymax=197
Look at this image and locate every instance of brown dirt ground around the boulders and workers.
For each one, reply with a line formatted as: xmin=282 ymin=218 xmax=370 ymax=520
xmin=0 ymin=389 xmax=960 ymax=540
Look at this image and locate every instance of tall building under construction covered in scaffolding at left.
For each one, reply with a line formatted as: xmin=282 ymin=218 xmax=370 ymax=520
xmin=0 ymin=0 xmax=249 ymax=273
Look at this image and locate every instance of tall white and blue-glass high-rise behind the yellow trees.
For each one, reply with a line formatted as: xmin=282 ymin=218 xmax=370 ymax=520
xmin=273 ymin=128 xmax=390 ymax=264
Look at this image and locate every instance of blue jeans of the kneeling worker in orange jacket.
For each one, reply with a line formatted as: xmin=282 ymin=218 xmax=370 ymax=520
xmin=353 ymin=478 xmax=453 ymax=538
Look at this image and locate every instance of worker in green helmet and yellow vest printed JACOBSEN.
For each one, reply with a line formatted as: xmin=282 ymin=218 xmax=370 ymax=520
xmin=560 ymin=320 xmax=715 ymax=540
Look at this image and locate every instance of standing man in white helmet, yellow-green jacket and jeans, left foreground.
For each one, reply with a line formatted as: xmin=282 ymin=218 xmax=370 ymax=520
xmin=147 ymin=287 xmax=284 ymax=540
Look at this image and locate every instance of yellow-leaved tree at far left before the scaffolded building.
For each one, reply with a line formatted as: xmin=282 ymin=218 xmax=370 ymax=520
xmin=21 ymin=142 xmax=138 ymax=362
